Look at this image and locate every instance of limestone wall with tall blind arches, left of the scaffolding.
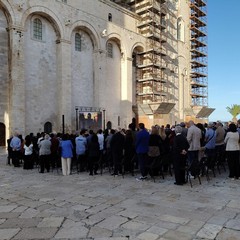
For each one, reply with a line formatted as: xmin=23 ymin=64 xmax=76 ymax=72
xmin=0 ymin=0 xmax=145 ymax=139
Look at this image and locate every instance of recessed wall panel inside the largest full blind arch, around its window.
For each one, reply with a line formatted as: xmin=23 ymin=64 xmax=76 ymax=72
xmin=24 ymin=14 xmax=60 ymax=133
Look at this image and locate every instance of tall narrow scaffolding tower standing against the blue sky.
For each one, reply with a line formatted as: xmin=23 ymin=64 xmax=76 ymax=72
xmin=190 ymin=0 xmax=208 ymax=106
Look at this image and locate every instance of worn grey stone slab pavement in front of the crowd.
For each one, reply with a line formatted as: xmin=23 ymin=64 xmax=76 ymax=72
xmin=0 ymin=146 xmax=240 ymax=240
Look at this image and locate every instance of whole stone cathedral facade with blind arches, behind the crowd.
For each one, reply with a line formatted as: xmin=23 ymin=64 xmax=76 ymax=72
xmin=0 ymin=0 xmax=210 ymax=145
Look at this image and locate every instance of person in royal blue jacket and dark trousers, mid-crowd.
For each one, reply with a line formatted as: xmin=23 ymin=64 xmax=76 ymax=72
xmin=135 ymin=123 xmax=150 ymax=180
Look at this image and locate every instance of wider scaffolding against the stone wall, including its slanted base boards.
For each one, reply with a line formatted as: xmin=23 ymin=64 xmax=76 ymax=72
xmin=114 ymin=0 xmax=175 ymax=115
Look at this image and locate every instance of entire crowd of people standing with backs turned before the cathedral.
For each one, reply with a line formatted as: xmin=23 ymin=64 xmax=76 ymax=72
xmin=5 ymin=120 xmax=240 ymax=185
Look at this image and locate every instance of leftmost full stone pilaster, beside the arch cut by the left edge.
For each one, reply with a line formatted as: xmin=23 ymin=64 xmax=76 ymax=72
xmin=8 ymin=26 xmax=25 ymax=134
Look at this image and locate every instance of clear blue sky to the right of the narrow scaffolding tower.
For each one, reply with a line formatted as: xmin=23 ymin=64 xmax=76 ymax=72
xmin=208 ymin=0 xmax=240 ymax=121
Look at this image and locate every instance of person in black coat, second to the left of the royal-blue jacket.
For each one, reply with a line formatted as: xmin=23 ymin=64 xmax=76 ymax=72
xmin=110 ymin=129 xmax=125 ymax=176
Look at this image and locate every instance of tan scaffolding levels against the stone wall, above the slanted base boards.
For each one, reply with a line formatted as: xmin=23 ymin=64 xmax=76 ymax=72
xmin=135 ymin=0 xmax=167 ymax=104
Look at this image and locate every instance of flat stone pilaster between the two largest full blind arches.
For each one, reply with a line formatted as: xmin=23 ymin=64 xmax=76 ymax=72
xmin=57 ymin=39 xmax=72 ymax=133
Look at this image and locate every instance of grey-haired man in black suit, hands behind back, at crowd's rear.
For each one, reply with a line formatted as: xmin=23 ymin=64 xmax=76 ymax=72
xmin=173 ymin=126 xmax=189 ymax=185
